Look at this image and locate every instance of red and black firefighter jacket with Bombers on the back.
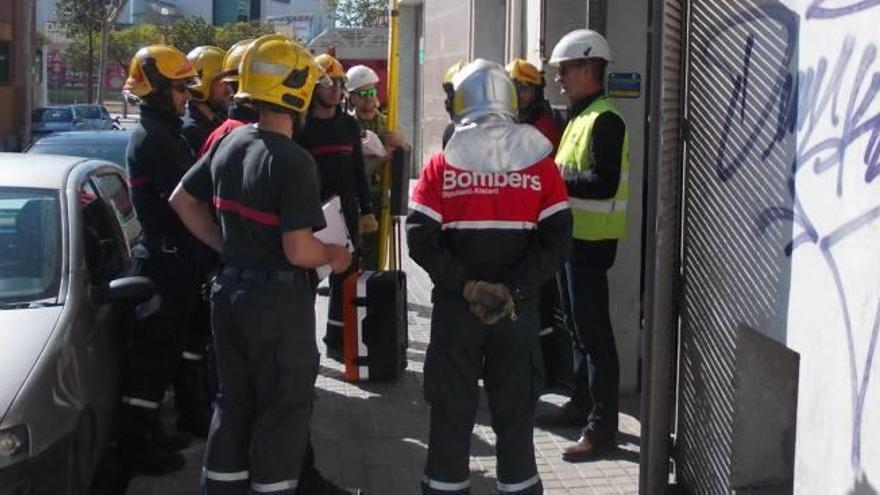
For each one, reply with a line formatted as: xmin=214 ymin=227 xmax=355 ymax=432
xmin=407 ymin=152 xmax=571 ymax=301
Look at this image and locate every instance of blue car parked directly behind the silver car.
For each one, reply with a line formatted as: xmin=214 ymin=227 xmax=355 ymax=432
xmin=25 ymin=129 xmax=131 ymax=167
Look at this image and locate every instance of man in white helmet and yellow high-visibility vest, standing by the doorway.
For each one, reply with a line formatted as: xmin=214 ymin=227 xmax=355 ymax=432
xmin=538 ymin=29 xmax=629 ymax=460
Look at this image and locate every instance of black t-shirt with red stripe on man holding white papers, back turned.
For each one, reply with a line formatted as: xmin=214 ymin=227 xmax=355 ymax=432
xmin=183 ymin=125 xmax=324 ymax=270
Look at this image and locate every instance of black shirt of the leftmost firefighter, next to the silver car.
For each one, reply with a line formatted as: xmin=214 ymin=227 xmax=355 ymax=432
xmin=125 ymin=105 xmax=196 ymax=248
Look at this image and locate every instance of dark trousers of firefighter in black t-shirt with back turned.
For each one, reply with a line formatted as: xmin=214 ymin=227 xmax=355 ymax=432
xmin=203 ymin=272 xmax=318 ymax=495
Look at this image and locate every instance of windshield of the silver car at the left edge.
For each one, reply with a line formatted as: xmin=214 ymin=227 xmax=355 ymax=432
xmin=0 ymin=187 xmax=61 ymax=307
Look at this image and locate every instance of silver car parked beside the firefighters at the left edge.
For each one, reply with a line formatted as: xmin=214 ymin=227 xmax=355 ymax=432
xmin=0 ymin=153 xmax=153 ymax=495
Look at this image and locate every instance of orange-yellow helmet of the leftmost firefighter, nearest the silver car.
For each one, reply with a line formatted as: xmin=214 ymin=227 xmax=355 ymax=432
xmin=122 ymin=45 xmax=198 ymax=98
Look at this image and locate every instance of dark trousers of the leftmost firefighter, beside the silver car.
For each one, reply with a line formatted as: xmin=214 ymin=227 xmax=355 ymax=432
xmin=119 ymin=248 xmax=198 ymax=462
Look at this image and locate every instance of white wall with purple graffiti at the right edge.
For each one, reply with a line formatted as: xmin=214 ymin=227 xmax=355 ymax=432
xmin=787 ymin=0 xmax=880 ymax=494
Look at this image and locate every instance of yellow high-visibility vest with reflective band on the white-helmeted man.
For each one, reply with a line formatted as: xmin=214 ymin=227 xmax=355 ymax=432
xmin=556 ymin=96 xmax=629 ymax=241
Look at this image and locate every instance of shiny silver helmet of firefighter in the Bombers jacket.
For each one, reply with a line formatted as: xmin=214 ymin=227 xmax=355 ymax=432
xmin=452 ymin=58 xmax=516 ymax=124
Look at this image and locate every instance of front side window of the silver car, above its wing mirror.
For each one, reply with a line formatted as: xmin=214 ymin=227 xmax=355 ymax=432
xmin=79 ymin=181 xmax=128 ymax=283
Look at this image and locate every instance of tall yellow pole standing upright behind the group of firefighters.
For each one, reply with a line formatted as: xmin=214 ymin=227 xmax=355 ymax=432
xmin=379 ymin=0 xmax=400 ymax=270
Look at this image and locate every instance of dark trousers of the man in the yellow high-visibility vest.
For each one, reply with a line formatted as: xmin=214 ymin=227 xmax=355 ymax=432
xmin=568 ymin=239 xmax=620 ymax=431
